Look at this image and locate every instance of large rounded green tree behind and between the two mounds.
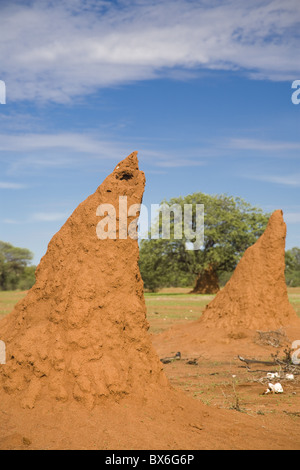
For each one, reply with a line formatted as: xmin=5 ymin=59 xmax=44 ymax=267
xmin=140 ymin=193 xmax=269 ymax=293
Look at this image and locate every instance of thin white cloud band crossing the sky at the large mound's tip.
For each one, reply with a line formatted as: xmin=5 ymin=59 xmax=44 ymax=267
xmin=0 ymin=131 xmax=300 ymax=175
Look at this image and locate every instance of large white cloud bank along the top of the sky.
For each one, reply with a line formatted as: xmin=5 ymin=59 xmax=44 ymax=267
xmin=0 ymin=0 xmax=300 ymax=102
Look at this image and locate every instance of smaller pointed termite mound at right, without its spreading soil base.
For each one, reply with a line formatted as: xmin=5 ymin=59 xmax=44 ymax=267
xmin=200 ymin=210 xmax=297 ymax=331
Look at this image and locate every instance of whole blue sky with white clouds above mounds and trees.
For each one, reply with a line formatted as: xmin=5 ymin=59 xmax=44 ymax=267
xmin=0 ymin=0 xmax=300 ymax=263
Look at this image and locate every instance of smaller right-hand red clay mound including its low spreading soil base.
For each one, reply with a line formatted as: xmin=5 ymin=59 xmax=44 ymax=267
xmin=153 ymin=210 xmax=300 ymax=359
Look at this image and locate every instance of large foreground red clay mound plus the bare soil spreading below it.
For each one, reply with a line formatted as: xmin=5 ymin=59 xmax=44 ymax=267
xmin=0 ymin=153 xmax=298 ymax=449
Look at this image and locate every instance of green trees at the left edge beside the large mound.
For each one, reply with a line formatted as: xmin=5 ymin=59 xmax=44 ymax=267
xmin=0 ymin=241 xmax=33 ymax=290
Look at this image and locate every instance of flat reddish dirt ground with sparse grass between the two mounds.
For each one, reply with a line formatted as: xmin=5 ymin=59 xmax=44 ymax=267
xmin=146 ymin=288 xmax=300 ymax=447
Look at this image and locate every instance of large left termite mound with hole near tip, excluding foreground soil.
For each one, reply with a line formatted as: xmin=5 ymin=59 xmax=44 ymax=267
xmin=0 ymin=152 xmax=166 ymax=408
